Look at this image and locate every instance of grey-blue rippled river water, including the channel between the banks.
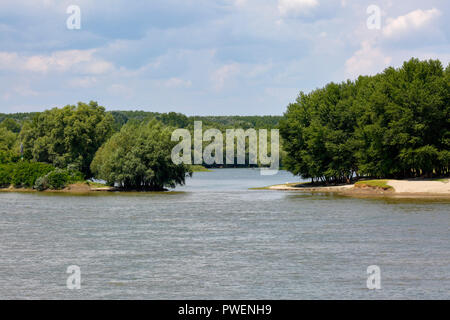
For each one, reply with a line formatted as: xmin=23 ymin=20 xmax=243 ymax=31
xmin=0 ymin=169 xmax=450 ymax=299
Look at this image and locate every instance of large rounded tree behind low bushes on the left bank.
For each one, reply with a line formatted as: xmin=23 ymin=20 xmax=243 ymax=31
xmin=20 ymin=101 xmax=114 ymax=177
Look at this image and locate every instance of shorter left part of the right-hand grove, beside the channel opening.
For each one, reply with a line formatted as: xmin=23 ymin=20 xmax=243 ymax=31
xmin=280 ymin=82 xmax=357 ymax=183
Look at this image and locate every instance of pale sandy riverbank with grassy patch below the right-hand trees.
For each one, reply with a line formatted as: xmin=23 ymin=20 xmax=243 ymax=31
xmin=262 ymin=179 xmax=450 ymax=198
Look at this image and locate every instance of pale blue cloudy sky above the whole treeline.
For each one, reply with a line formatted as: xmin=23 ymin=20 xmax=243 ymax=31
xmin=0 ymin=0 xmax=450 ymax=115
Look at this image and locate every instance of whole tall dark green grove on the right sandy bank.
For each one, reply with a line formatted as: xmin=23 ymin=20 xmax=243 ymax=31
xmin=280 ymin=59 xmax=450 ymax=183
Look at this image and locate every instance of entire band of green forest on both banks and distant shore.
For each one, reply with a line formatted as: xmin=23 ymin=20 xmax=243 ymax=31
xmin=0 ymin=59 xmax=450 ymax=190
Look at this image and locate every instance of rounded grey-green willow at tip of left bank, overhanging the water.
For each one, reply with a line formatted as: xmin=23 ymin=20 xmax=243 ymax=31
xmin=91 ymin=120 xmax=192 ymax=191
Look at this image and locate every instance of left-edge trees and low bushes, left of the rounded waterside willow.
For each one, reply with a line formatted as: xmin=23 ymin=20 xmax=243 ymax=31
xmin=0 ymin=102 xmax=114 ymax=190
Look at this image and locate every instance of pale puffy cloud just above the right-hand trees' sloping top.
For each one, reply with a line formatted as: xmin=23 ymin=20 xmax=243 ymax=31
xmin=345 ymin=41 xmax=392 ymax=78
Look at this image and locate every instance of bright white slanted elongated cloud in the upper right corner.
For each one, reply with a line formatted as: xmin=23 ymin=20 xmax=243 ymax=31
xmin=383 ymin=8 xmax=441 ymax=38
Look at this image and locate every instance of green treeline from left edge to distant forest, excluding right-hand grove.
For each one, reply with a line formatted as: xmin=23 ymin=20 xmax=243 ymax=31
xmin=0 ymin=102 xmax=280 ymax=190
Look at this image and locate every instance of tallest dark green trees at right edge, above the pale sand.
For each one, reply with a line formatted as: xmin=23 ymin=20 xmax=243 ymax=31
xmin=357 ymin=59 xmax=450 ymax=178
